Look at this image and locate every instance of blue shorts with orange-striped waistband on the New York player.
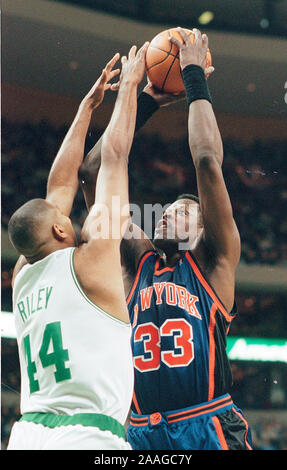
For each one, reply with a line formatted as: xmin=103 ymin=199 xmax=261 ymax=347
xmin=127 ymin=394 xmax=252 ymax=450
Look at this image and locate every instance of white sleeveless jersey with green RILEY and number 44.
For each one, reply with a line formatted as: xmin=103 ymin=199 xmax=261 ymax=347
xmin=13 ymin=248 xmax=134 ymax=424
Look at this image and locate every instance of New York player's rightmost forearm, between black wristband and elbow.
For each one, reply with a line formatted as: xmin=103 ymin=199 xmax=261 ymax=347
xmin=188 ymin=99 xmax=223 ymax=167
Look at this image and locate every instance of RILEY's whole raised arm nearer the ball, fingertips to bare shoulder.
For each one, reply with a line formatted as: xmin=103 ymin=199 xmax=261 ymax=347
xmin=75 ymin=44 xmax=151 ymax=321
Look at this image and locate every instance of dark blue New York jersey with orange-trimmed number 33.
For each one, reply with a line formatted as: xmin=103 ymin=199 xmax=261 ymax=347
xmin=127 ymin=251 xmax=236 ymax=414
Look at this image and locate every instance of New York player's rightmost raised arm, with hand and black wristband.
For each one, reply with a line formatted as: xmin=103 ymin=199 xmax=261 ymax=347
xmin=172 ymin=29 xmax=240 ymax=306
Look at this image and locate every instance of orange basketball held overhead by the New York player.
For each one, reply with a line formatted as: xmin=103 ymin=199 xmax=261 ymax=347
xmin=146 ymin=28 xmax=212 ymax=93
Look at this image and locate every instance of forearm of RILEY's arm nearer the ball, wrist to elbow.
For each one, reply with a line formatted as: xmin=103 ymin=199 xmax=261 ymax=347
xmin=101 ymin=79 xmax=137 ymax=161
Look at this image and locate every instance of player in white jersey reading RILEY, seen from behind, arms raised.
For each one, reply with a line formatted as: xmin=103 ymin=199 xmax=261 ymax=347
xmin=8 ymin=43 xmax=148 ymax=450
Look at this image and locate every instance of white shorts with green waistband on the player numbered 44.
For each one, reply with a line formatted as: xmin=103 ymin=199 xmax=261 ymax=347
xmin=7 ymin=413 xmax=131 ymax=450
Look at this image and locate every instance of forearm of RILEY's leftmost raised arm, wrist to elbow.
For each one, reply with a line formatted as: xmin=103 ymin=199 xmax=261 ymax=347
xmin=47 ymin=102 xmax=92 ymax=193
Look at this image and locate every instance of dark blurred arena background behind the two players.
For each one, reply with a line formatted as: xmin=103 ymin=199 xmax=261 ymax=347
xmin=1 ymin=0 xmax=287 ymax=450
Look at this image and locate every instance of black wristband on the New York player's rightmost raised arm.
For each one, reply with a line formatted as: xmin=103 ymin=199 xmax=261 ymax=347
xmin=182 ymin=65 xmax=212 ymax=106
